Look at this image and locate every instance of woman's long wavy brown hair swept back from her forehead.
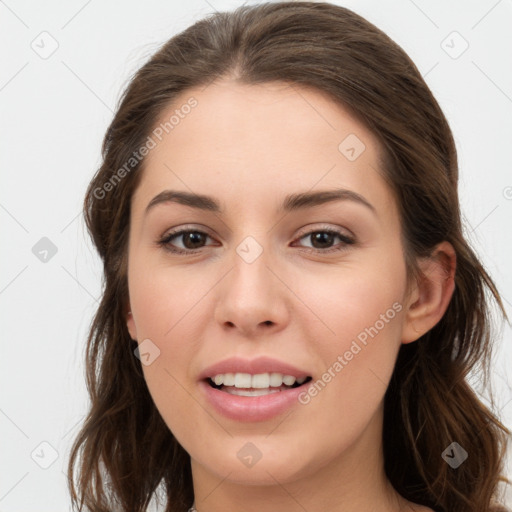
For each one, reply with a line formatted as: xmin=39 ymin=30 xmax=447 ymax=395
xmin=68 ymin=2 xmax=510 ymax=512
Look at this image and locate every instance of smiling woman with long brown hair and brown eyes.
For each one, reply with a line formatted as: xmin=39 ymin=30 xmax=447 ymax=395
xmin=69 ymin=2 xmax=510 ymax=512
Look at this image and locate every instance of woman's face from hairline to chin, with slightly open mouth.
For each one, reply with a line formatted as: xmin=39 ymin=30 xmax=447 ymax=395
xmin=127 ymin=80 xmax=411 ymax=484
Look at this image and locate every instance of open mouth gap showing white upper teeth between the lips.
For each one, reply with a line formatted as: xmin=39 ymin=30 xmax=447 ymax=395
xmin=204 ymin=372 xmax=312 ymax=397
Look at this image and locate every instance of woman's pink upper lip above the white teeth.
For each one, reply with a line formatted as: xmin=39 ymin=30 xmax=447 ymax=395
xmin=199 ymin=357 xmax=311 ymax=380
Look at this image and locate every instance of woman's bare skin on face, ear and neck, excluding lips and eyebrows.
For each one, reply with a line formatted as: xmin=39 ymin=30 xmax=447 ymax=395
xmin=127 ymin=79 xmax=455 ymax=512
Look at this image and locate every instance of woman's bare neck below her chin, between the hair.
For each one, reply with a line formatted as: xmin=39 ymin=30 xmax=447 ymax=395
xmin=191 ymin=406 xmax=408 ymax=512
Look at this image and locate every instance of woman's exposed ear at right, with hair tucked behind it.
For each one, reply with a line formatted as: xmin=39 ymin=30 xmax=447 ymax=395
xmin=402 ymin=242 xmax=457 ymax=343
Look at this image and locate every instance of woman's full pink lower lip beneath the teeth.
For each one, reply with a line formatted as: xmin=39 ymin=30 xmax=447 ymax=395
xmin=199 ymin=381 xmax=307 ymax=422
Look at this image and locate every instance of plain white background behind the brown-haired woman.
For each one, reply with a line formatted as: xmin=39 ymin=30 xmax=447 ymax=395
xmin=0 ymin=0 xmax=512 ymax=512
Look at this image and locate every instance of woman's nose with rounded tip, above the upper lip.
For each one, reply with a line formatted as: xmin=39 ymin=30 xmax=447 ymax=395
xmin=215 ymin=245 xmax=291 ymax=338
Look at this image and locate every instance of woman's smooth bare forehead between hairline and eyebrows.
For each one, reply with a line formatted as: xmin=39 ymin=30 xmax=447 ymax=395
xmin=130 ymin=80 xmax=389 ymax=218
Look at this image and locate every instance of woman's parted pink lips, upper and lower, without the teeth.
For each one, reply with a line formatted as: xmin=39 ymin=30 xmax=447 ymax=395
xmin=199 ymin=357 xmax=311 ymax=422
